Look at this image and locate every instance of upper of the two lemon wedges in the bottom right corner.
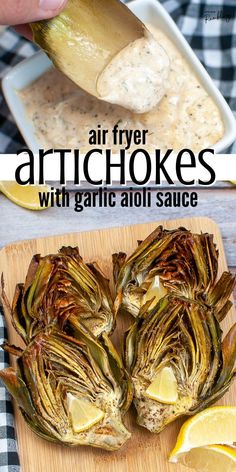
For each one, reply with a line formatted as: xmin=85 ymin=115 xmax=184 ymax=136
xmin=169 ymin=406 xmax=236 ymax=462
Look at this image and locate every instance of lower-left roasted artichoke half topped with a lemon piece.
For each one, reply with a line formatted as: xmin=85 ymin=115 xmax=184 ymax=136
xmin=0 ymin=326 xmax=132 ymax=450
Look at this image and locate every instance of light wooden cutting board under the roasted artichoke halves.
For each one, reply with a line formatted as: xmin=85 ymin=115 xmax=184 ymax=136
xmin=0 ymin=218 xmax=236 ymax=472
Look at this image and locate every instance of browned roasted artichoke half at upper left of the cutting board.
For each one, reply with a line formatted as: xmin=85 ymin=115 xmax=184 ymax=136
xmin=2 ymin=247 xmax=114 ymax=343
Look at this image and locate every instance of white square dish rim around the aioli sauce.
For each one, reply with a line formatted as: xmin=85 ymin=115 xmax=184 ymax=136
xmin=2 ymin=0 xmax=236 ymax=153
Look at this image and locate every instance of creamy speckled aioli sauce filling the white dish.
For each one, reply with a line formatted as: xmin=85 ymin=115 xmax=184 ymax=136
xmin=20 ymin=27 xmax=224 ymax=152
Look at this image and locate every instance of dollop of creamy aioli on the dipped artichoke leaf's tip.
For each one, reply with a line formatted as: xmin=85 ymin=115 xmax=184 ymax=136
xmin=97 ymin=31 xmax=170 ymax=113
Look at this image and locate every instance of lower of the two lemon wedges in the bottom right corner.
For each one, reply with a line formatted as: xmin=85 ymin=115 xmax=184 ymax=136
xmin=181 ymin=445 xmax=236 ymax=472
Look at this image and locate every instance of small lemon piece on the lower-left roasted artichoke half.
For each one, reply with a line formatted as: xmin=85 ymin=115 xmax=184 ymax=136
xmin=67 ymin=393 xmax=104 ymax=433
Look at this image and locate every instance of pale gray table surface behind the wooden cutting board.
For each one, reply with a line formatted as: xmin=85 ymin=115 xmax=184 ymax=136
xmin=0 ymin=183 xmax=236 ymax=295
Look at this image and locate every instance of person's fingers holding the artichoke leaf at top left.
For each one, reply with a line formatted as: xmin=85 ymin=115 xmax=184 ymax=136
xmin=0 ymin=0 xmax=67 ymax=39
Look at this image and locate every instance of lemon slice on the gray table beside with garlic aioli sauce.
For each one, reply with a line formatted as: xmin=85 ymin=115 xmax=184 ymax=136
xmin=0 ymin=181 xmax=50 ymax=210
